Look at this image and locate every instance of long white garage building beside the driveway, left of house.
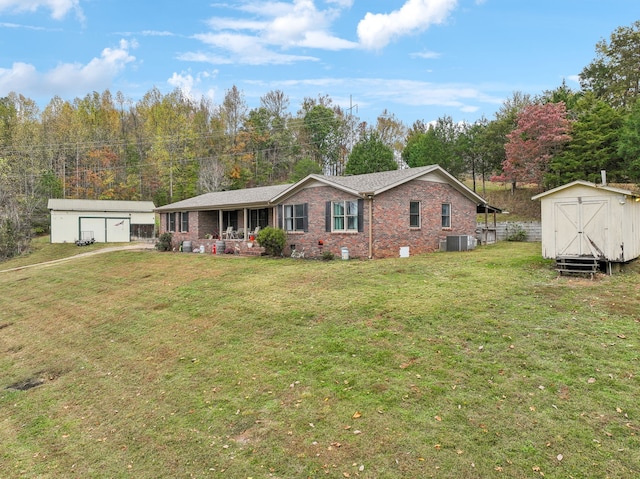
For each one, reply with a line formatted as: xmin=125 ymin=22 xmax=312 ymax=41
xmin=48 ymin=199 xmax=155 ymax=243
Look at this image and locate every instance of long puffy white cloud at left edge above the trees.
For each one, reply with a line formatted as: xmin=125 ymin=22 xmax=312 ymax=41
xmin=0 ymin=40 xmax=135 ymax=96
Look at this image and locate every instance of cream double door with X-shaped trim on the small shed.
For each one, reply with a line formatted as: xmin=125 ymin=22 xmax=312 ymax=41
xmin=554 ymin=199 xmax=609 ymax=258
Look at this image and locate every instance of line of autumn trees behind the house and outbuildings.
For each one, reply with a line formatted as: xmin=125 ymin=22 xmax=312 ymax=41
xmin=0 ymin=22 xmax=640 ymax=259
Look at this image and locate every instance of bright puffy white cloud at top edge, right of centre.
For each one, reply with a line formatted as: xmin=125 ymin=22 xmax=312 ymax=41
xmin=358 ymin=0 xmax=458 ymax=50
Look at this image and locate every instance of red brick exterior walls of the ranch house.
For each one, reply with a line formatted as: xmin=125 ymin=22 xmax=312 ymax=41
xmin=160 ymin=180 xmax=476 ymax=258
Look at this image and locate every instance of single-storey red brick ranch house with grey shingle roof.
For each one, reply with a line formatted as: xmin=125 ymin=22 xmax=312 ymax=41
xmin=156 ymin=165 xmax=486 ymax=258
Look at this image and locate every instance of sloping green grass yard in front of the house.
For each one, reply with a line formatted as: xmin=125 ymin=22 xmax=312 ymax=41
xmin=0 ymin=243 xmax=640 ymax=479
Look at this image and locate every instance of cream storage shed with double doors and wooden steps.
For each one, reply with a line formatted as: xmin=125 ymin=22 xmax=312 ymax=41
xmin=532 ymin=181 xmax=640 ymax=266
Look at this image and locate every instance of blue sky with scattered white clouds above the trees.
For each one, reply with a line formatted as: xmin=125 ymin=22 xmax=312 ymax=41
xmin=0 ymin=0 xmax=640 ymax=126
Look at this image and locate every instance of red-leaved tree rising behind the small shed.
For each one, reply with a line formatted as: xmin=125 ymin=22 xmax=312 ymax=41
xmin=492 ymin=102 xmax=571 ymax=188
